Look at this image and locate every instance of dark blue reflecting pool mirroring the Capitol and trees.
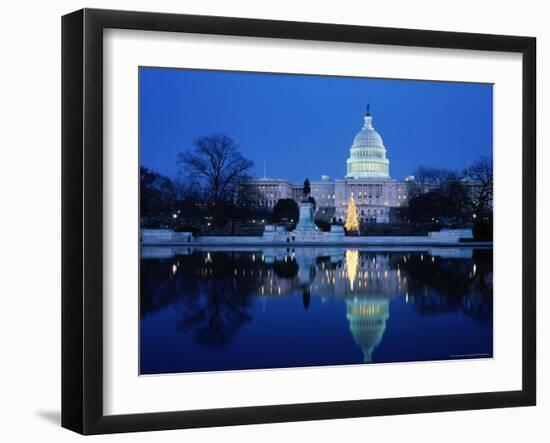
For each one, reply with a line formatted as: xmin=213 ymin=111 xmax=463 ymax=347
xmin=140 ymin=247 xmax=493 ymax=374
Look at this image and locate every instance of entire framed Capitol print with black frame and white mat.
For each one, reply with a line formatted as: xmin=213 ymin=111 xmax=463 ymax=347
xmin=62 ymin=9 xmax=536 ymax=434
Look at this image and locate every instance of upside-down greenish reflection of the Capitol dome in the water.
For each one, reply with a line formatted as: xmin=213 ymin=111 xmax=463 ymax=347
xmin=346 ymin=299 xmax=390 ymax=363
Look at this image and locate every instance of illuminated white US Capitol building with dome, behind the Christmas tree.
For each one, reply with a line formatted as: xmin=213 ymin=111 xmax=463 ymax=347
xmin=252 ymin=107 xmax=414 ymax=223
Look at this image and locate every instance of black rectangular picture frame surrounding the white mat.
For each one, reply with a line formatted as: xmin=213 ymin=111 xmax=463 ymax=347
xmin=62 ymin=9 xmax=536 ymax=434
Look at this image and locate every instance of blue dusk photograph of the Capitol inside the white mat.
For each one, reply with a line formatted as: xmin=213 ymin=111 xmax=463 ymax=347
xmin=136 ymin=66 xmax=494 ymax=375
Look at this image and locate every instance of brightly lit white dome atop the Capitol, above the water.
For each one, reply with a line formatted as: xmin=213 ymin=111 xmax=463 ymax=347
xmin=346 ymin=107 xmax=390 ymax=179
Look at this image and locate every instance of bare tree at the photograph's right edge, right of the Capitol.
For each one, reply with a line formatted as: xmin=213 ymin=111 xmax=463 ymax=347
xmin=464 ymin=157 xmax=493 ymax=216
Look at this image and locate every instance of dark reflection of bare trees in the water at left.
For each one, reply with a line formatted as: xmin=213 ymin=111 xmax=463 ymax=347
xmin=141 ymin=253 xmax=262 ymax=347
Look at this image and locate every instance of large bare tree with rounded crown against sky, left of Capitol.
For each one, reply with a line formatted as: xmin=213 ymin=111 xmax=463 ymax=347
xmin=178 ymin=134 xmax=253 ymax=203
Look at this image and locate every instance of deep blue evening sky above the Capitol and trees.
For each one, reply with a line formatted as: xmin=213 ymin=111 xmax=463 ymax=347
xmin=139 ymin=67 xmax=493 ymax=182
